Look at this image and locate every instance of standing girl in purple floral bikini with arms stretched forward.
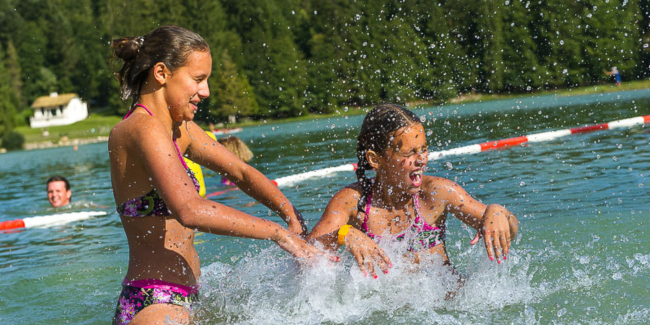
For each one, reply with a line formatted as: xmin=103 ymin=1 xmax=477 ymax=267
xmin=108 ymin=26 xmax=337 ymax=324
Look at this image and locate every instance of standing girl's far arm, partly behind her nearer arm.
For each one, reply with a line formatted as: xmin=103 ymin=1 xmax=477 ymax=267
xmin=186 ymin=122 xmax=307 ymax=236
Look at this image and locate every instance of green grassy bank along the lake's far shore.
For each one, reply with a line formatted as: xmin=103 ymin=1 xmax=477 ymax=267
xmin=16 ymin=80 xmax=650 ymax=143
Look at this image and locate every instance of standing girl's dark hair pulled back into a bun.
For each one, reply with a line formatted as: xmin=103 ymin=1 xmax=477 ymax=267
xmin=111 ymin=25 xmax=210 ymax=104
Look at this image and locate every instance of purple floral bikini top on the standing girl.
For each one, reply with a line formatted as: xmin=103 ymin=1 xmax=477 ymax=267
xmin=117 ymin=104 xmax=201 ymax=217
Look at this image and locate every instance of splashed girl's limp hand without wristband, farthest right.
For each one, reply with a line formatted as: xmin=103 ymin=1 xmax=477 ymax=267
xmin=470 ymin=204 xmax=519 ymax=263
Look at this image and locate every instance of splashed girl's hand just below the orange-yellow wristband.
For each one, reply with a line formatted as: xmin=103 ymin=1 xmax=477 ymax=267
xmin=345 ymin=228 xmax=393 ymax=279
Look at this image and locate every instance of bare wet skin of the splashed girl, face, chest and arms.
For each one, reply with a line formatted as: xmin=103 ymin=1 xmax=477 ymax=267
xmin=308 ymin=124 xmax=518 ymax=276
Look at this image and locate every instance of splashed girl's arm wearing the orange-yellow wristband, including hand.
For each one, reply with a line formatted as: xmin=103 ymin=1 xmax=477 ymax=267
xmin=307 ymin=187 xmax=392 ymax=278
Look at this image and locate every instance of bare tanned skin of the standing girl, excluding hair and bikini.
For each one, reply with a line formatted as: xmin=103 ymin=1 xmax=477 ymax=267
xmin=108 ymin=51 xmax=330 ymax=286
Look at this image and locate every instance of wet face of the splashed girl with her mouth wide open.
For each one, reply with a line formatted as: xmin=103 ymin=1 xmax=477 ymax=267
xmin=377 ymin=123 xmax=429 ymax=194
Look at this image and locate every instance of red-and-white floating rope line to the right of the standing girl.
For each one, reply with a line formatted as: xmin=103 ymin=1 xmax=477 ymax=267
xmin=206 ymin=115 xmax=650 ymax=192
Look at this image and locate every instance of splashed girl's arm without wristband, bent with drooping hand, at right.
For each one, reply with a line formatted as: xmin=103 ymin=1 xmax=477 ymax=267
xmin=427 ymin=177 xmax=519 ymax=262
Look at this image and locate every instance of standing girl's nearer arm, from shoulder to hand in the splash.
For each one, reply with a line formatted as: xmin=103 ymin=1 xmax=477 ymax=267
xmin=128 ymin=123 xmax=321 ymax=258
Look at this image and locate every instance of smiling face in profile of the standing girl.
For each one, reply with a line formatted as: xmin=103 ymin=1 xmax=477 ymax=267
xmin=166 ymin=51 xmax=212 ymax=122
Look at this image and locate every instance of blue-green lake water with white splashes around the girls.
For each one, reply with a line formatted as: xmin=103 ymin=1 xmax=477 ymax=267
xmin=0 ymin=91 xmax=650 ymax=324
